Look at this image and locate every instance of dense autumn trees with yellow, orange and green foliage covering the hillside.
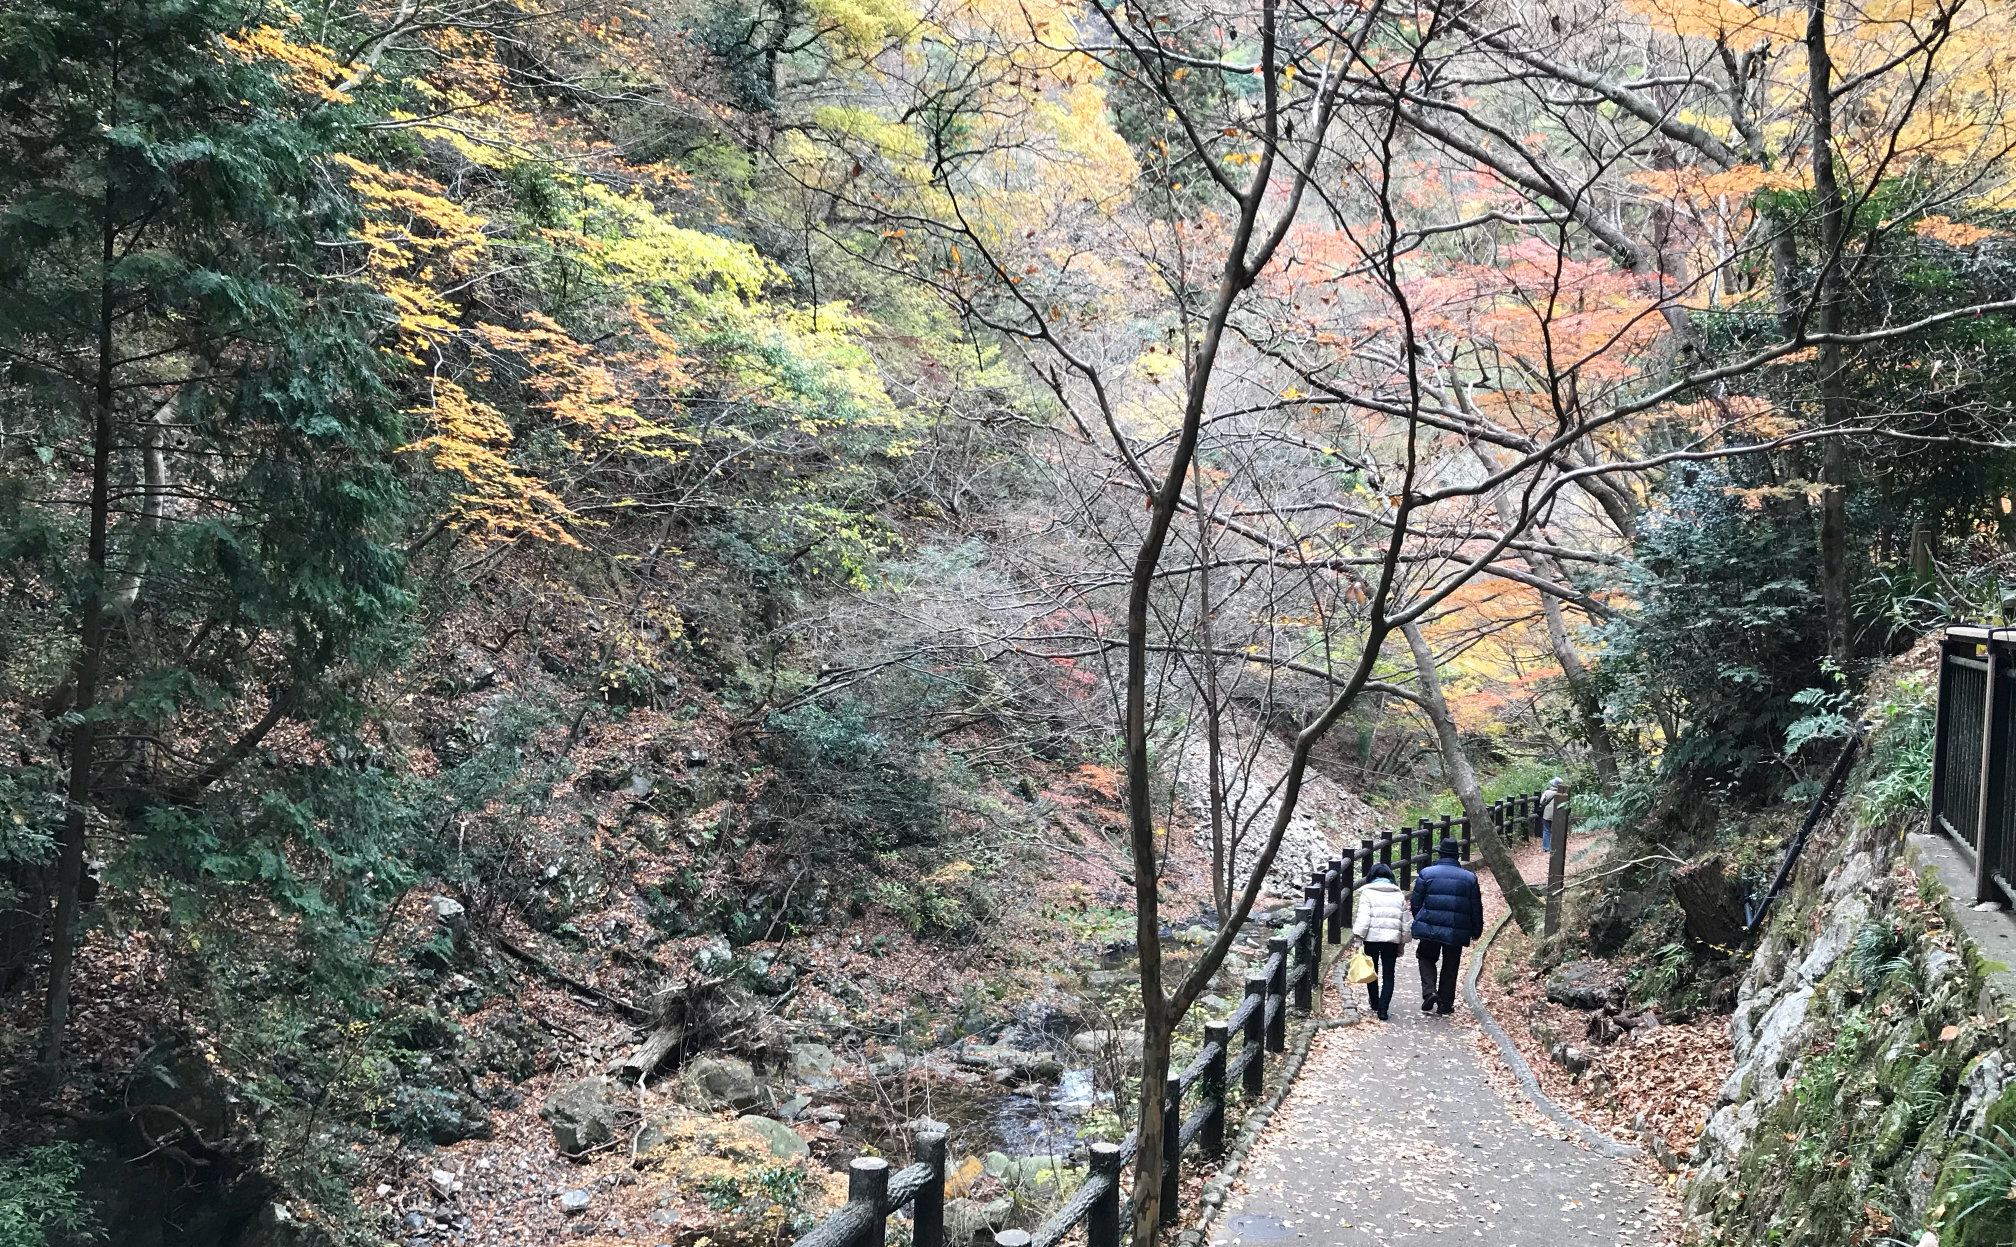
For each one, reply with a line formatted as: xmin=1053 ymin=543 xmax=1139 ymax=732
xmin=0 ymin=0 xmax=2016 ymax=1243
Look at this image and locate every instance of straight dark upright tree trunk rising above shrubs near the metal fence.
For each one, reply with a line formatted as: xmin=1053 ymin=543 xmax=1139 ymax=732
xmin=1806 ymin=0 xmax=1855 ymax=671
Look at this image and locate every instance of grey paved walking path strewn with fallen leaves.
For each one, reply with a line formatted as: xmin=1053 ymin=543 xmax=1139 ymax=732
xmin=1210 ymin=838 xmax=1679 ymax=1247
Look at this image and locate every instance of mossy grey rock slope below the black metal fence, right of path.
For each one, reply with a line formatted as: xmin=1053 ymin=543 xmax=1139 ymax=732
xmin=1687 ymin=809 xmax=2016 ymax=1247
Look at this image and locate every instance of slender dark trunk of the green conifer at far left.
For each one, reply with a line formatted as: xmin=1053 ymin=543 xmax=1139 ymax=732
xmin=42 ymin=200 xmax=117 ymax=1068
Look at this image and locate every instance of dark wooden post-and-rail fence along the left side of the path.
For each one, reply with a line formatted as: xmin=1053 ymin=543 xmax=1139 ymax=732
xmin=798 ymin=809 xmax=1516 ymax=1247
